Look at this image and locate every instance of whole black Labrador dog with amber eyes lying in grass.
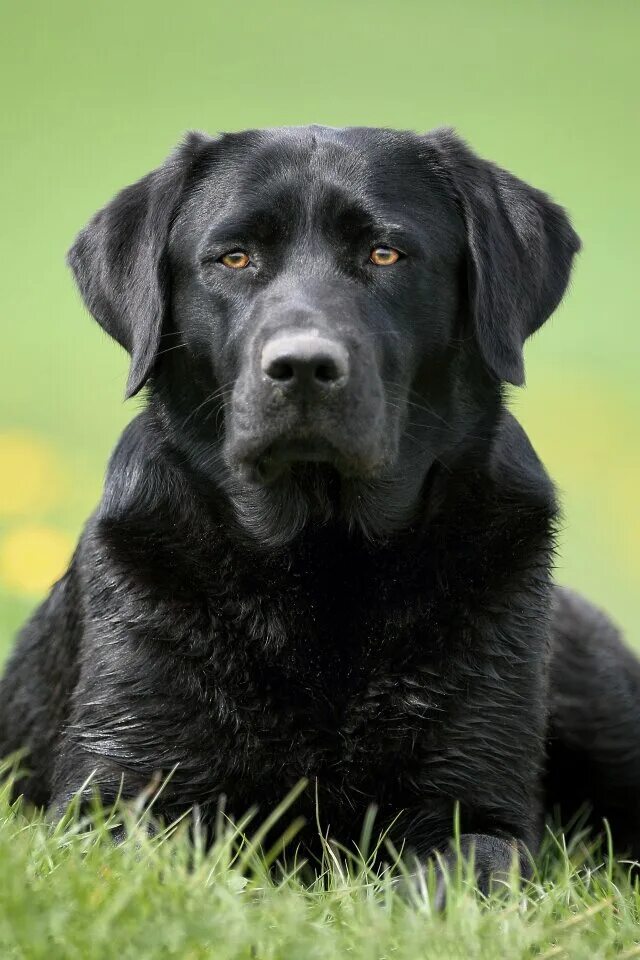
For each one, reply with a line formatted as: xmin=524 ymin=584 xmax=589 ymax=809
xmin=0 ymin=127 xmax=640 ymax=884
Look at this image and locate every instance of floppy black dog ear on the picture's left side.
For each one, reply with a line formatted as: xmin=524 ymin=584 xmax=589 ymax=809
xmin=67 ymin=133 xmax=211 ymax=398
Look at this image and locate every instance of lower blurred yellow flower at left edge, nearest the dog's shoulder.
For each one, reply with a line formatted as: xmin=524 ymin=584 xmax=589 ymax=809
xmin=0 ymin=524 xmax=73 ymax=596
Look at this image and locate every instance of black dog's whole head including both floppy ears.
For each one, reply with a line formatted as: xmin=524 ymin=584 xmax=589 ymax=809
xmin=70 ymin=127 xmax=578 ymax=544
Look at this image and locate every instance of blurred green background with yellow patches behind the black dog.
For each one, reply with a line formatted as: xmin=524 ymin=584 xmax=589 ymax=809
xmin=0 ymin=0 xmax=640 ymax=653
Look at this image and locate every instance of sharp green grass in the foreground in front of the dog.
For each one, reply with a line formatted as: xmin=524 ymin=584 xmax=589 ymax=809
xmin=0 ymin=764 xmax=640 ymax=960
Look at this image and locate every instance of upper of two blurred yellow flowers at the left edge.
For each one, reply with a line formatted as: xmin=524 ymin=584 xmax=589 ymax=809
xmin=0 ymin=433 xmax=66 ymax=518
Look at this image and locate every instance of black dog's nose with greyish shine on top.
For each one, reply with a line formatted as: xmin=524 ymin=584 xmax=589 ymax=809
xmin=260 ymin=330 xmax=349 ymax=390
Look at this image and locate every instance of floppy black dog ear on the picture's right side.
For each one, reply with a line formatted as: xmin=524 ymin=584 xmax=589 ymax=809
xmin=426 ymin=130 xmax=580 ymax=386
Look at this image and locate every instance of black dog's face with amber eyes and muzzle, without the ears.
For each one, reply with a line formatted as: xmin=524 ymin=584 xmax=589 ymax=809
xmin=169 ymin=130 xmax=463 ymax=483
